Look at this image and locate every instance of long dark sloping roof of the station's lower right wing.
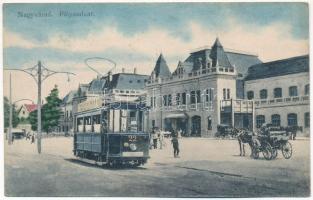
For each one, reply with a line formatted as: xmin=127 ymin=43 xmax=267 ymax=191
xmin=245 ymin=55 xmax=309 ymax=80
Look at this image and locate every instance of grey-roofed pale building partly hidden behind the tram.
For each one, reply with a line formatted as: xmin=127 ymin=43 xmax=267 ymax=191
xmin=60 ymin=70 xmax=149 ymax=132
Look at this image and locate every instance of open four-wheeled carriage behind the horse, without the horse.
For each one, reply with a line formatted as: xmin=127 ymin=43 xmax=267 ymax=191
xmin=251 ymin=124 xmax=292 ymax=160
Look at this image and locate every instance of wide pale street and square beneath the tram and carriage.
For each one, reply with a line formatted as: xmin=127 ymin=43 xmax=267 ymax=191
xmin=4 ymin=137 xmax=310 ymax=197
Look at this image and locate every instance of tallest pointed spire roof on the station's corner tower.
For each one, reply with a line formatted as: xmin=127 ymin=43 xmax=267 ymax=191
xmin=210 ymin=38 xmax=232 ymax=67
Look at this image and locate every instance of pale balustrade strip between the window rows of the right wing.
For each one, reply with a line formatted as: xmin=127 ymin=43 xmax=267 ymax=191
xmin=254 ymin=95 xmax=310 ymax=108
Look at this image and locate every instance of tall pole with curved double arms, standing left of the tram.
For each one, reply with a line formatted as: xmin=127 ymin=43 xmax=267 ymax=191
xmin=4 ymin=61 xmax=76 ymax=154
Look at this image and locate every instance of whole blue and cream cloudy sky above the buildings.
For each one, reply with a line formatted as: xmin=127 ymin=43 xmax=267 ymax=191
xmin=3 ymin=3 xmax=309 ymax=104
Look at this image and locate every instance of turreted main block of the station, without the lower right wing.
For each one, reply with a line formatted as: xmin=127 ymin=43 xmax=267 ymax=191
xmin=146 ymin=39 xmax=261 ymax=137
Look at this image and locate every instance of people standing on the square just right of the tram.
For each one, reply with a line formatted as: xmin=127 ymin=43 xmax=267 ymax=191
xmin=151 ymin=128 xmax=181 ymax=158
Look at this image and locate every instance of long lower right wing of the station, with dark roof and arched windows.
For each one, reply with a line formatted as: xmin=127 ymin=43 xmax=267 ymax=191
xmin=245 ymin=55 xmax=310 ymax=135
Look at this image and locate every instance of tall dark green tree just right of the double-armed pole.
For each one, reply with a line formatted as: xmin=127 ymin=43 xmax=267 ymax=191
xmin=28 ymin=86 xmax=62 ymax=133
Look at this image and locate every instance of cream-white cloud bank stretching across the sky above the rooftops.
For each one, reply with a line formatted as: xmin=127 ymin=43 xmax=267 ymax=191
xmin=4 ymin=20 xmax=309 ymax=99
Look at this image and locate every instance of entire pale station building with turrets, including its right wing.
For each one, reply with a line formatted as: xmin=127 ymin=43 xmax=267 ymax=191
xmin=146 ymin=39 xmax=310 ymax=137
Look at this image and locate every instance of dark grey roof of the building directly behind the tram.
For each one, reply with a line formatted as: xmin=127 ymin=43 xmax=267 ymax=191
xmin=105 ymin=73 xmax=149 ymax=90
